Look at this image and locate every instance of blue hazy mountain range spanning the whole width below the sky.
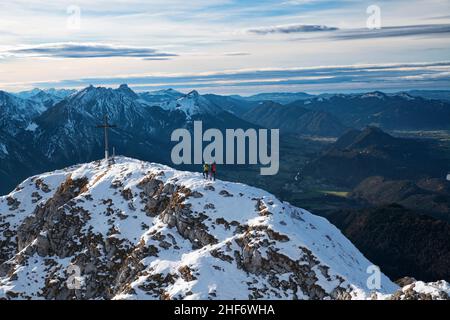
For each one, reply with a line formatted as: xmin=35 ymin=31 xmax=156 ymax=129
xmin=0 ymin=85 xmax=450 ymax=193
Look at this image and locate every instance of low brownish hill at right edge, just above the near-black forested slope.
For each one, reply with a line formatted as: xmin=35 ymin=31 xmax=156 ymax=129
xmin=349 ymin=177 xmax=450 ymax=223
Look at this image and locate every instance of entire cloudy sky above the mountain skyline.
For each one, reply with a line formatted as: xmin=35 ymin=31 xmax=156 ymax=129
xmin=0 ymin=0 xmax=450 ymax=94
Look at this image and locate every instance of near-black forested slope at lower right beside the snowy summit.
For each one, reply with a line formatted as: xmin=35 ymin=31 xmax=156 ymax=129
xmin=328 ymin=205 xmax=450 ymax=281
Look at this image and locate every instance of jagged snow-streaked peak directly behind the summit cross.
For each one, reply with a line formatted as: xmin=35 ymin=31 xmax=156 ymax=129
xmin=33 ymin=86 xmax=184 ymax=165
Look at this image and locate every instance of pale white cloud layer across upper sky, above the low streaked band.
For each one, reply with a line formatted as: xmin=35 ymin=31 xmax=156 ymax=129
xmin=0 ymin=0 xmax=450 ymax=94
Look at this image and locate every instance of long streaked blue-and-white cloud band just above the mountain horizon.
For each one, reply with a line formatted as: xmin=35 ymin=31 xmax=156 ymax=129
xmin=2 ymin=62 xmax=450 ymax=93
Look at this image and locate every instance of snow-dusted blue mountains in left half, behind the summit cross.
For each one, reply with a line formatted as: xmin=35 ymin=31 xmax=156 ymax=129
xmin=0 ymin=85 xmax=254 ymax=192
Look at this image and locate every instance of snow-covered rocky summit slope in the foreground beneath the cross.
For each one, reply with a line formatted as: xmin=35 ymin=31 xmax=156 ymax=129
xmin=0 ymin=158 xmax=397 ymax=299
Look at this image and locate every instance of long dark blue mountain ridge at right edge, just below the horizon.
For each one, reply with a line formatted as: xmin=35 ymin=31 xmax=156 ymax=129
xmin=299 ymin=92 xmax=450 ymax=130
